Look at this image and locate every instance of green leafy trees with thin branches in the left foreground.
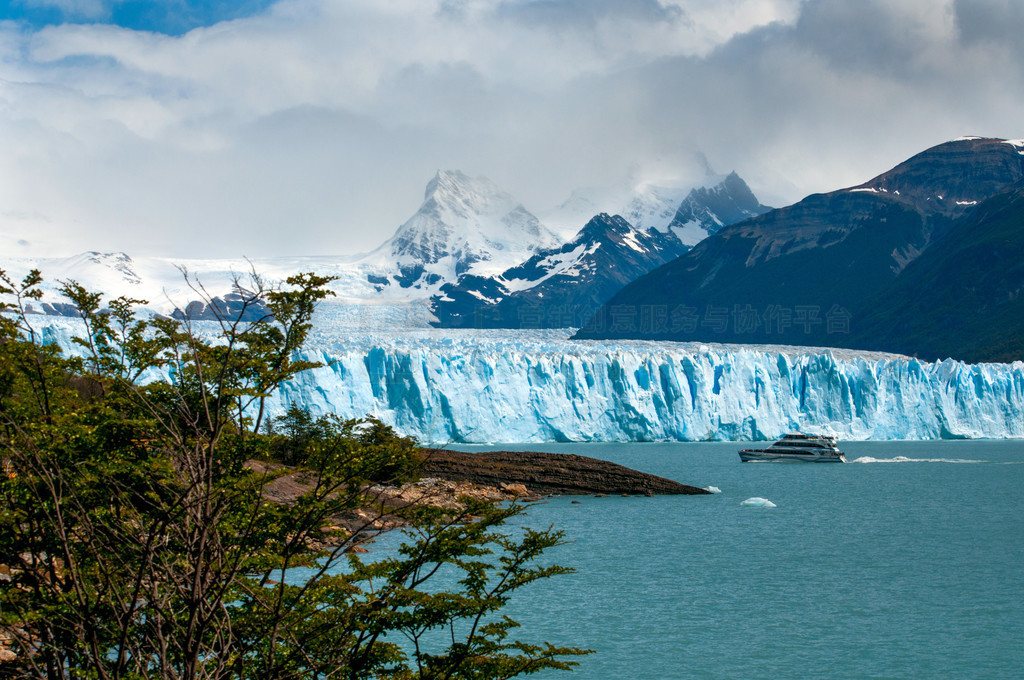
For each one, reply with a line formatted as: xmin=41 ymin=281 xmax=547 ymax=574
xmin=0 ymin=271 xmax=583 ymax=679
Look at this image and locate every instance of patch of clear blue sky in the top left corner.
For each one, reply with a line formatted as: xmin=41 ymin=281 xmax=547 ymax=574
xmin=0 ymin=0 xmax=273 ymax=36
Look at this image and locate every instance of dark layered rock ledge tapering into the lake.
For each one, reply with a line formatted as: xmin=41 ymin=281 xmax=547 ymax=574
xmin=422 ymin=449 xmax=710 ymax=496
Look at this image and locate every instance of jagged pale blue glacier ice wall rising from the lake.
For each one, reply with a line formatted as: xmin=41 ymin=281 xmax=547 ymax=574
xmin=29 ymin=314 xmax=1024 ymax=444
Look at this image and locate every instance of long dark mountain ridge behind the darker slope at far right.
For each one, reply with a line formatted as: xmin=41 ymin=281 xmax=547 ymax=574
xmin=577 ymin=137 xmax=1024 ymax=364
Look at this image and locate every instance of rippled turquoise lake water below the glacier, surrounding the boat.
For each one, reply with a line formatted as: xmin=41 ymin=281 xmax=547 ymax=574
xmin=409 ymin=441 xmax=1024 ymax=680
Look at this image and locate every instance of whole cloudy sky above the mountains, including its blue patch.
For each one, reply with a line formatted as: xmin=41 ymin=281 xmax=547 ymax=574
xmin=0 ymin=0 xmax=1024 ymax=257
